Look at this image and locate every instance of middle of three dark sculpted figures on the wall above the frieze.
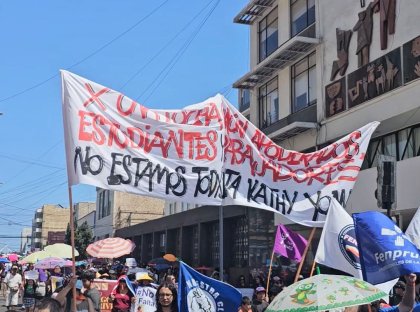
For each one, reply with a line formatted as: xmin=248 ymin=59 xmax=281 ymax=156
xmin=353 ymin=2 xmax=374 ymax=67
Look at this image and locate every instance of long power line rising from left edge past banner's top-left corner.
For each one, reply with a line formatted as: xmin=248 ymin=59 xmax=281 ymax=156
xmin=0 ymin=0 xmax=169 ymax=103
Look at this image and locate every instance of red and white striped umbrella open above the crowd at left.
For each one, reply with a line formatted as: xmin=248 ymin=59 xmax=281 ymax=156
xmin=86 ymin=237 xmax=136 ymax=259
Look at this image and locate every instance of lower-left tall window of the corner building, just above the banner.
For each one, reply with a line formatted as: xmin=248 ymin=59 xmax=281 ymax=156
xmin=259 ymin=77 xmax=279 ymax=129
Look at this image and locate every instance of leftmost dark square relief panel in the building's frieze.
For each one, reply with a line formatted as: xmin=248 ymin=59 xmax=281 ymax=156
xmin=325 ymin=77 xmax=346 ymax=117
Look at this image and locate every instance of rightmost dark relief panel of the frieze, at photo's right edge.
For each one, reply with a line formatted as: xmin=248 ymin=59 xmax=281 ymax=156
xmin=403 ymin=36 xmax=420 ymax=83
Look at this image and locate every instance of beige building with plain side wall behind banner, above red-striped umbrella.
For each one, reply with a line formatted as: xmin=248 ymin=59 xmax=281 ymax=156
xmin=94 ymin=188 xmax=165 ymax=240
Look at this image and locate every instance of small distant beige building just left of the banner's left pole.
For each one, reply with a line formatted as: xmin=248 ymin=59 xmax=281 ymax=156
xmin=32 ymin=204 xmax=70 ymax=250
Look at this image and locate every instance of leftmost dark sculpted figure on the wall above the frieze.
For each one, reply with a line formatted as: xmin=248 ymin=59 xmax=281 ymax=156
xmin=330 ymin=28 xmax=353 ymax=81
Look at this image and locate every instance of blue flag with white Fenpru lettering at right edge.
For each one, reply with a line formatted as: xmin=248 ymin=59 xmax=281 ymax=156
xmin=353 ymin=211 xmax=420 ymax=284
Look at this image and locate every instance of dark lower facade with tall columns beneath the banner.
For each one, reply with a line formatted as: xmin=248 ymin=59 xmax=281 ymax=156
xmin=115 ymin=204 xmax=275 ymax=284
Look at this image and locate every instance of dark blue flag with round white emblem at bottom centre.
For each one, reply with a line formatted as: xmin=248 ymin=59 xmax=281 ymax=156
xmin=178 ymin=261 xmax=242 ymax=312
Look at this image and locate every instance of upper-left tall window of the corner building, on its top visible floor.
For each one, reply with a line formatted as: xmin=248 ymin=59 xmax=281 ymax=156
xmin=258 ymin=7 xmax=278 ymax=62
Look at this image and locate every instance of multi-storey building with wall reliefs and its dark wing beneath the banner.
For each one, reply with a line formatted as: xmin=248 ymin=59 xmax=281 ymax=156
xmin=116 ymin=0 xmax=420 ymax=282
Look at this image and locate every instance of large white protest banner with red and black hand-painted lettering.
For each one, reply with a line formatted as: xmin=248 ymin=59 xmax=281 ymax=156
xmin=62 ymin=71 xmax=379 ymax=227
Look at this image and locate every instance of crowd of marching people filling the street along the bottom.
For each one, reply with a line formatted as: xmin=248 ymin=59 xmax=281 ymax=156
xmin=0 ymin=263 xmax=420 ymax=312
